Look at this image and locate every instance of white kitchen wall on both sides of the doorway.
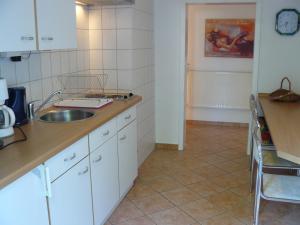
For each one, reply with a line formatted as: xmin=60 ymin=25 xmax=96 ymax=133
xmin=154 ymin=0 xmax=300 ymax=144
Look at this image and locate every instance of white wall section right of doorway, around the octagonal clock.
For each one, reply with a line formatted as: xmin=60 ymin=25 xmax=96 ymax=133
xmin=258 ymin=0 xmax=300 ymax=93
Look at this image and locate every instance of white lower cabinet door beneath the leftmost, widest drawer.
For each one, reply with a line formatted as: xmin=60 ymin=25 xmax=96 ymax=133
xmin=49 ymin=157 xmax=93 ymax=225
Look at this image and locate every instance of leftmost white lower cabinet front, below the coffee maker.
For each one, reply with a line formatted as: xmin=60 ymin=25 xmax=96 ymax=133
xmin=0 ymin=166 xmax=49 ymax=225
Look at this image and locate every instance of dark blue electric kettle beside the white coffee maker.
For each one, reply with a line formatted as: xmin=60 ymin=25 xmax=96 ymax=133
xmin=5 ymin=87 xmax=28 ymax=126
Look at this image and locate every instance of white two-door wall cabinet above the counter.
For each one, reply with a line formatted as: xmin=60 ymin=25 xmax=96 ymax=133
xmin=0 ymin=0 xmax=77 ymax=52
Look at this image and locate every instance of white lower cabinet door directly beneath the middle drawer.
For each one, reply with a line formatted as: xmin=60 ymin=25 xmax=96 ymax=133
xmin=90 ymin=136 xmax=119 ymax=225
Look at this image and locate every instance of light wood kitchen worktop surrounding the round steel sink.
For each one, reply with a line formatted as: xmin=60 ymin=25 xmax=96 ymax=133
xmin=0 ymin=96 xmax=142 ymax=189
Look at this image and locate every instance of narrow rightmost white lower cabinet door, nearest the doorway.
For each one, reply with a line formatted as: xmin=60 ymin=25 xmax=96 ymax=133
xmin=118 ymin=120 xmax=138 ymax=197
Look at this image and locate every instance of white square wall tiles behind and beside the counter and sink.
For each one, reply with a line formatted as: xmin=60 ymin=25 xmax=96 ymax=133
xmin=0 ymin=0 xmax=155 ymax=163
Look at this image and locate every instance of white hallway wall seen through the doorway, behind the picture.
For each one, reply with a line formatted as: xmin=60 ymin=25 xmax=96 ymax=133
xmin=186 ymin=4 xmax=256 ymax=123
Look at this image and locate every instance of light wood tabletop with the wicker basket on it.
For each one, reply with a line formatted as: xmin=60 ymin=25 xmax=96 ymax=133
xmin=258 ymin=94 xmax=300 ymax=164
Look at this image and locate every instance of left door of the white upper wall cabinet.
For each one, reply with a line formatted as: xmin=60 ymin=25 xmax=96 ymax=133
xmin=0 ymin=0 xmax=36 ymax=52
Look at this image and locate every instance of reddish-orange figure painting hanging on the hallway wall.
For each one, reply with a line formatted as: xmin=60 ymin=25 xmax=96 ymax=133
xmin=205 ymin=19 xmax=255 ymax=58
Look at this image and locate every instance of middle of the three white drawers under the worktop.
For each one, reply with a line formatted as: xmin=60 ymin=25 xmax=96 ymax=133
xmin=89 ymin=119 xmax=117 ymax=152
